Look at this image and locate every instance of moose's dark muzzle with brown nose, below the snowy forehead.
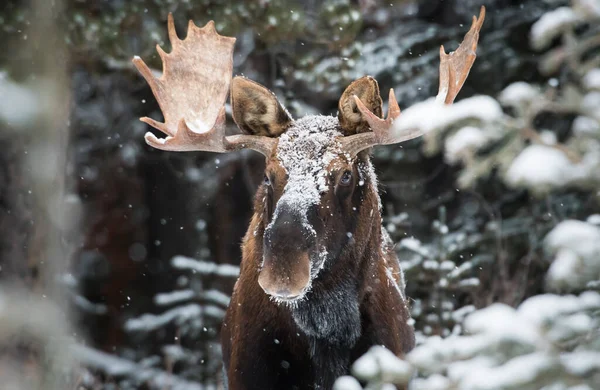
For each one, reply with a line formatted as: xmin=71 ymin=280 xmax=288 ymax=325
xmin=258 ymin=200 xmax=316 ymax=300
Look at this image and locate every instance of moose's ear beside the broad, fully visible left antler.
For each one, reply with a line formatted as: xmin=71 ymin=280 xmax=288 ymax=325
xmin=231 ymin=77 xmax=293 ymax=137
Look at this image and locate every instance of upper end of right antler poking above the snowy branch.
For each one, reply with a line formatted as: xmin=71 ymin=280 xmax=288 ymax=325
xmin=436 ymin=6 xmax=485 ymax=104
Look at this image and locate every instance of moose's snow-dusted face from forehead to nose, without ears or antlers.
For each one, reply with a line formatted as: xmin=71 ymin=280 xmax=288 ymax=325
xmin=258 ymin=116 xmax=366 ymax=302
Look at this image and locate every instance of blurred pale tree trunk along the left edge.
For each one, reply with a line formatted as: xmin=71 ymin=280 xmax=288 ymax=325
xmin=0 ymin=0 xmax=78 ymax=389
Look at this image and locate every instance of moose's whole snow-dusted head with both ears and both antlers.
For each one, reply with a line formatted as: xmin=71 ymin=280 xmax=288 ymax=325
xmin=133 ymin=9 xmax=484 ymax=303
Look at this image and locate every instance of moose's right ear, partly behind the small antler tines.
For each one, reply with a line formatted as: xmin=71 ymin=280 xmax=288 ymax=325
xmin=338 ymin=76 xmax=383 ymax=135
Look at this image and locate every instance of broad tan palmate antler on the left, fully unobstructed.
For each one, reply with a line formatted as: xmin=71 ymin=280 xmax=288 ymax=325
xmin=133 ymin=14 xmax=275 ymax=155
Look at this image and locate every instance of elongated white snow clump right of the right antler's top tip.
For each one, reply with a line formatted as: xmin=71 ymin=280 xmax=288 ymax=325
xmin=529 ymin=7 xmax=581 ymax=50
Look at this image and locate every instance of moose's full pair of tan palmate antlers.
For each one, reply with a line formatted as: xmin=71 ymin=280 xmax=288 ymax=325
xmin=133 ymin=7 xmax=485 ymax=157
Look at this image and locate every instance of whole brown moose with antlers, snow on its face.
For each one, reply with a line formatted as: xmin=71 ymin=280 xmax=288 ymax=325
xmin=133 ymin=7 xmax=485 ymax=390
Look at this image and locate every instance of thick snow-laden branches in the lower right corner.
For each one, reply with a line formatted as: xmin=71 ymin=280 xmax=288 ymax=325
xmin=337 ymin=291 xmax=600 ymax=390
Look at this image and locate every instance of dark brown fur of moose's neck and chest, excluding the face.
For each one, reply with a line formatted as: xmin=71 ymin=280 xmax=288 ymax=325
xmin=221 ymin=158 xmax=414 ymax=390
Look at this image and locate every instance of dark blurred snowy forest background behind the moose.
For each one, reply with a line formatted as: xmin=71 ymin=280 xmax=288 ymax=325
xmin=0 ymin=0 xmax=600 ymax=389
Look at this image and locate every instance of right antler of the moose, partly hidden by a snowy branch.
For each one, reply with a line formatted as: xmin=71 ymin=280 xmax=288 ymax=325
xmin=340 ymin=6 xmax=485 ymax=156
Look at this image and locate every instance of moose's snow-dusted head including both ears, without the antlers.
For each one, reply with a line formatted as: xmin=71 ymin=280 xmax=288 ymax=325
xmin=231 ymin=78 xmax=381 ymax=303
